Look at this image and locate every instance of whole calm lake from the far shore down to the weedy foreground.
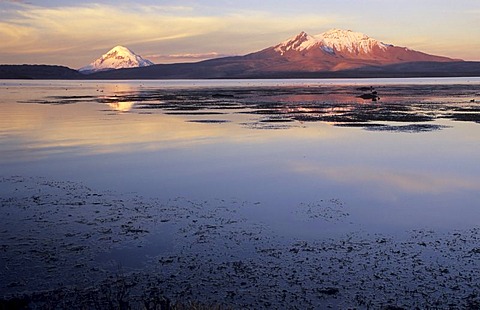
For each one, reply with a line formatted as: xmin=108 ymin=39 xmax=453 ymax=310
xmin=0 ymin=78 xmax=480 ymax=308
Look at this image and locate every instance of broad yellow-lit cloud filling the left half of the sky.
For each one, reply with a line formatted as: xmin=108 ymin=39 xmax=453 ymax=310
xmin=0 ymin=4 xmax=221 ymax=53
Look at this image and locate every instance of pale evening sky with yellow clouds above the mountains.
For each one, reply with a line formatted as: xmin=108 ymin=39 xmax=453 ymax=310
xmin=0 ymin=0 xmax=480 ymax=69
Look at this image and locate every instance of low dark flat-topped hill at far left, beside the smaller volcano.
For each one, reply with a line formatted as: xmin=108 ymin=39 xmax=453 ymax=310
xmin=0 ymin=65 xmax=84 ymax=80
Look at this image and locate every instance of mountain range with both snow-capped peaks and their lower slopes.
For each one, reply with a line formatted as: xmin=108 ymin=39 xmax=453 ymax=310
xmin=0 ymin=29 xmax=480 ymax=79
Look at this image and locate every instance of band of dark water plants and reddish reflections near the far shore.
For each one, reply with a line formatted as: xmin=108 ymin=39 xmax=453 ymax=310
xmin=21 ymin=84 xmax=480 ymax=132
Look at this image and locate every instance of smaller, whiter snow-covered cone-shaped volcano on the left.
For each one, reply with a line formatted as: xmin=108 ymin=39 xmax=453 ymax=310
xmin=78 ymin=46 xmax=153 ymax=73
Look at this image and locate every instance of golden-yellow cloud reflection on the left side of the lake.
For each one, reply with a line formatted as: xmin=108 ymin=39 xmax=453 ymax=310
xmin=0 ymin=97 xmax=340 ymax=161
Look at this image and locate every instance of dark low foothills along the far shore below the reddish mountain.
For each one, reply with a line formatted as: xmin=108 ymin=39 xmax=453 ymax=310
xmin=88 ymin=57 xmax=480 ymax=80
